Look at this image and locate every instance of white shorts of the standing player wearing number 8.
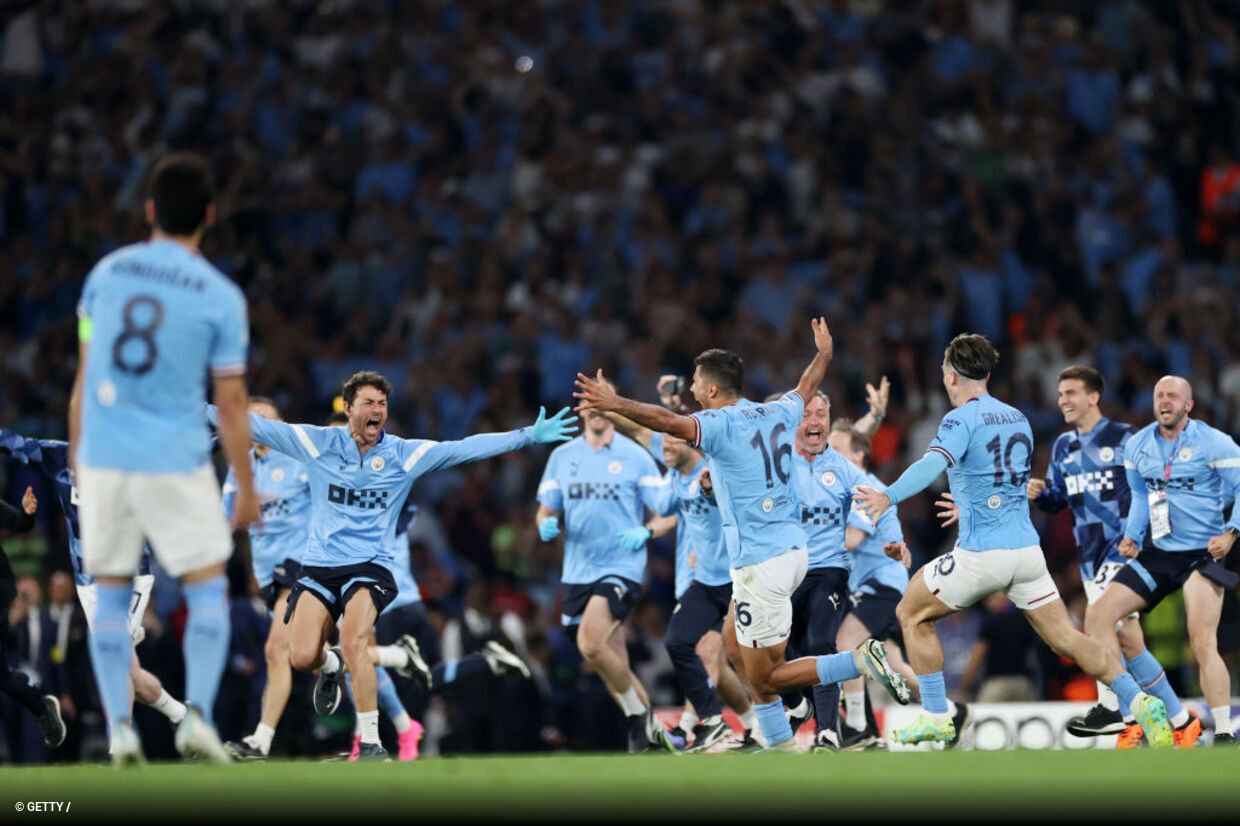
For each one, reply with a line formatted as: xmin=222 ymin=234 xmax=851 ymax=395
xmin=77 ymin=465 xmax=232 ymax=578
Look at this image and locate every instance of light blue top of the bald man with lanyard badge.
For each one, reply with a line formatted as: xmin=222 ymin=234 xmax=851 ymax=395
xmin=1123 ymin=419 xmax=1240 ymax=551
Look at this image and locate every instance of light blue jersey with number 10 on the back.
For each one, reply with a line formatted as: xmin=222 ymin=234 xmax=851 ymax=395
xmin=926 ymin=394 xmax=1039 ymax=551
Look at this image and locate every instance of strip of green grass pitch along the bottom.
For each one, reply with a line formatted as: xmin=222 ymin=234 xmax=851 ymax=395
xmin=0 ymin=749 xmax=1240 ymax=824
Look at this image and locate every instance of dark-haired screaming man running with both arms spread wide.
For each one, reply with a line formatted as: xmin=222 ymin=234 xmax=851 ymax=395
xmin=207 ymin=371 xmax=577 ymax=759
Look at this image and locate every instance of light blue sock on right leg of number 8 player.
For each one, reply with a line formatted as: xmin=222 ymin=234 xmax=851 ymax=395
xmin=182 ymin=574 xmax=229 ymax=722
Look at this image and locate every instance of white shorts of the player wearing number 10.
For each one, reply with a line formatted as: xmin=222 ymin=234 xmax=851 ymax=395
xmin=923 ymin=544 xmax=1059 ymax=611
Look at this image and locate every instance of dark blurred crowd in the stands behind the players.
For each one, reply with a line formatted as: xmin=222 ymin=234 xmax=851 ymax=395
xmin=0 ymin=0 xmax=1240 ymax=747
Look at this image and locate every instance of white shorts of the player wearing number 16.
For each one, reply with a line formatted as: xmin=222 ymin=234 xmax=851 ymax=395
xmin=732 ymin=548 xmax=810 ymax=649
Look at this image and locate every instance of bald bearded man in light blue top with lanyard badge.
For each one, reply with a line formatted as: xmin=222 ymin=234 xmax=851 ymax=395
xmin=1085 ymin=376 xmax=1240 ymax=744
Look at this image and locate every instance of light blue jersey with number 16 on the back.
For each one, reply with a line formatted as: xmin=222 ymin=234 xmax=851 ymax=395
xmin=693 ymin=391 xmax=807 ymax=568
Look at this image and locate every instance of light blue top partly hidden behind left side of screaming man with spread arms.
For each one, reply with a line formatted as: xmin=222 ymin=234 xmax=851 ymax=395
xmin=223 ymin=450 xmax=310 ymax=588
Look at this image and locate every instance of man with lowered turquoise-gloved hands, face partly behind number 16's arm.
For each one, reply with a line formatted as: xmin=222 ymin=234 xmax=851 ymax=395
xmin=536 ymin=412 xmax=673 ymax=753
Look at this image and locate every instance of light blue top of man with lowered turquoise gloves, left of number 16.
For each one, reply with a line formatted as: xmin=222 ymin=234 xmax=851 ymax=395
xmin=538 ymin=433 xmax=663 ymax=585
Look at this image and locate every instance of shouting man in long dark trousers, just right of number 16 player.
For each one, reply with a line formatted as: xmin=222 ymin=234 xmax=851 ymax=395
xmin=788 ymin=391 xmax=904 ymax=752
